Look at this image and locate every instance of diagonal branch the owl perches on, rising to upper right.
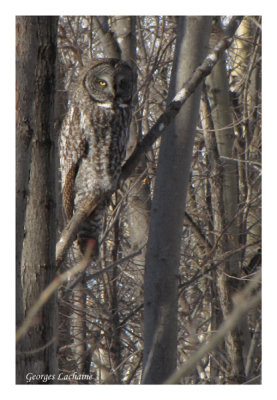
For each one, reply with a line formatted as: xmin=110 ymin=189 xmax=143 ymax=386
xmin=56 ymin=17 xmax=243 ymax=266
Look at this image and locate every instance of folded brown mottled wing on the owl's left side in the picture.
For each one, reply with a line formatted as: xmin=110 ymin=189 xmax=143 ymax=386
xmin=60 ymin=107 xmax=88 ymax=220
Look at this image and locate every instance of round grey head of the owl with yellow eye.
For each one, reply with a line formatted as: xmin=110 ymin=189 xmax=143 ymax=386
xmin=82 ymin=58 xmax=133 ymax=108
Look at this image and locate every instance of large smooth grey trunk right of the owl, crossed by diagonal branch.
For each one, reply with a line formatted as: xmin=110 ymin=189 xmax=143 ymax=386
xmin=144 ymin=17 xmax=211 ymax=384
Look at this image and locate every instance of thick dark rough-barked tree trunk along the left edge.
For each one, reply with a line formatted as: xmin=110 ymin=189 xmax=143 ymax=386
xmin=16 ymin=17 xmax=57 ymax=383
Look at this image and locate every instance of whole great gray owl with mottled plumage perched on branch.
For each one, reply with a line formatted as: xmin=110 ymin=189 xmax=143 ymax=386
xmin=60 ymin=58 xmax=133 ymax=253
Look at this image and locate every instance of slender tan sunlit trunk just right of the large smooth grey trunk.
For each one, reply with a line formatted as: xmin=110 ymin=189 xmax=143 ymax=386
xmin=206 ymin=21 xmax=248 ymax=383
